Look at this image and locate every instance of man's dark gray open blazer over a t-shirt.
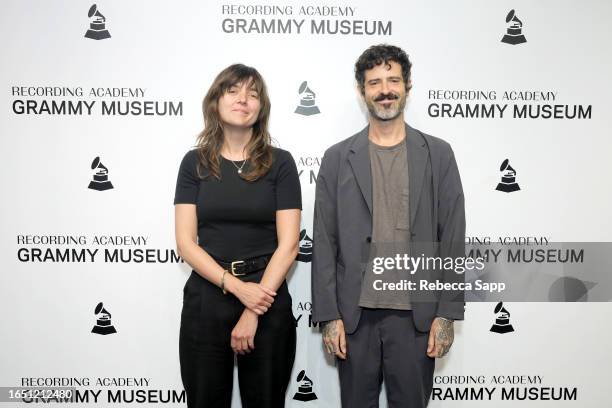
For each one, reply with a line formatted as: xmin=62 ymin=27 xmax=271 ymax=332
xmin=312 ymin=125 xmax=465 ymax=334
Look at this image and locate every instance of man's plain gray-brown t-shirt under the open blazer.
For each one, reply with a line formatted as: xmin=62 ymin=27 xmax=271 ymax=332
xmin=359 ymin=139 xmax=412 ymax=310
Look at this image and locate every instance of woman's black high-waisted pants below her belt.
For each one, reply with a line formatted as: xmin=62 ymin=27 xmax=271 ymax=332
xmin=179 ymin=270 xmax=295 ymax=408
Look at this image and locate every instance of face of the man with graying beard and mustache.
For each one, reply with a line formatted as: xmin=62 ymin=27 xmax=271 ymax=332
xmin=363 ymin=61 xmax=406 ymax=121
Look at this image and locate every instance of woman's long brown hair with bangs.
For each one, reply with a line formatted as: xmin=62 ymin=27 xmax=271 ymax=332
xmin=196 ymin=64 xmax=272 ymax=181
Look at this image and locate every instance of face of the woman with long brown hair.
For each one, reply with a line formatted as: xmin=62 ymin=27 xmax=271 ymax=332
xmin=218 ymin=81 xmax=261 ymax=128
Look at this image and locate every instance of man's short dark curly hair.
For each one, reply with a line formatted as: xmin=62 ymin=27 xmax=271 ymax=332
xmin=355 ymin=44 xmax=412 ymax=94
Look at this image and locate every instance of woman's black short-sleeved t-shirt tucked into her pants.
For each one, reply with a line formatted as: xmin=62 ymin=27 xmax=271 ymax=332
xmin=174 ymin=147 xmax=302 ymax=261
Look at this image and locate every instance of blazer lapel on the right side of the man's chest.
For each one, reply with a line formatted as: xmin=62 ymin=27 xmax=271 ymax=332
xmin=406 ymin=124 xmax=429 ymax=229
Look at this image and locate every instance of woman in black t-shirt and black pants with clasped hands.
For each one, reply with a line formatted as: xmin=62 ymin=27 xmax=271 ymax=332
xmin=174 ymin=64 xmax=302 ymax=408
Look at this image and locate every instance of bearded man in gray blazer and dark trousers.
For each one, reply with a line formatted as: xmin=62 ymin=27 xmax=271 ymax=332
xmin=312 ymin=45 xmax=465 ymax=408
